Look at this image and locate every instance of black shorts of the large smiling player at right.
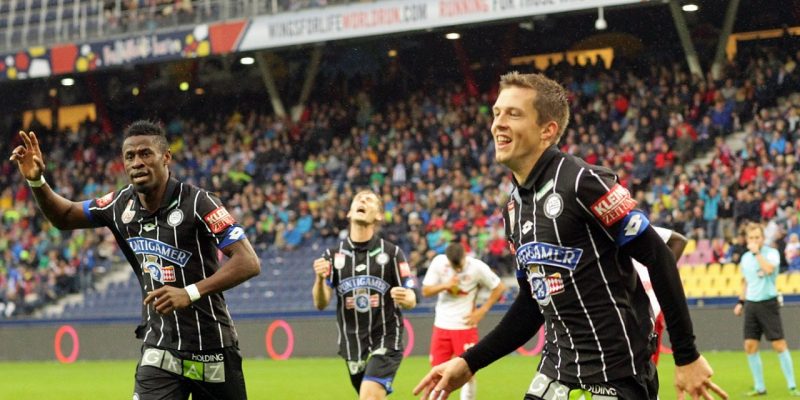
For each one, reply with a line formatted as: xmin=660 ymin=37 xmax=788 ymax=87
xmin=524 ymin=362 xmax=658 ymax=400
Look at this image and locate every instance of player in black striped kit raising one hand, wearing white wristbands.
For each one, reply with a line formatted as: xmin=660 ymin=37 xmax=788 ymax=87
xmin=11 ymin=121 xmax=261 ymax=400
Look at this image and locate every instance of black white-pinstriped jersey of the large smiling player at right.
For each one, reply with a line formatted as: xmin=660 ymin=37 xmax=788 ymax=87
xmin=503 ymin=146 xmax=653 ymax=383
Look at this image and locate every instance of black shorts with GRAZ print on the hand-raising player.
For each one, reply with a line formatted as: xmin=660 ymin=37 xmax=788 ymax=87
xmin=133 ymin=345 xmax=247 ymax=400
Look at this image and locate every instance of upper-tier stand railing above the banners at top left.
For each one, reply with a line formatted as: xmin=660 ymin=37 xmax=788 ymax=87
xmin=0 ymin=0 xmax=388 ymax=51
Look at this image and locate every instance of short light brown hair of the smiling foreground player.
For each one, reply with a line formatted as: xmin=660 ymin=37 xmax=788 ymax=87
xmin=500 ymin=71 xmax=569 ymax=144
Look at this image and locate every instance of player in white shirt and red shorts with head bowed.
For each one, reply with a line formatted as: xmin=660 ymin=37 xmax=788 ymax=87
xmin=422 ymin=242 xmax=505 ymax=400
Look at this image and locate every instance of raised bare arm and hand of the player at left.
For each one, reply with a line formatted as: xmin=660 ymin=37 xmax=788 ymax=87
xmin=10 ymin=131 xmax=95 ymax=230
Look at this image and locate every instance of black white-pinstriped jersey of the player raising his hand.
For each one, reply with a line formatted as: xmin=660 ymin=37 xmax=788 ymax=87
xmin=83 ymin=177 xmax=245 ymax=351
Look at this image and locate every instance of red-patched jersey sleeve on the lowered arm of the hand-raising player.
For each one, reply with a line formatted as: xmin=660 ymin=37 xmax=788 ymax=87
xmin=194 ymin=190 xmax=246 ymax=249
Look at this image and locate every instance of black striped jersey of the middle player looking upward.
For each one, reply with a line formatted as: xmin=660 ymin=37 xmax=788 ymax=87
xmin=322 ymin=236 xmax=415 ymax=361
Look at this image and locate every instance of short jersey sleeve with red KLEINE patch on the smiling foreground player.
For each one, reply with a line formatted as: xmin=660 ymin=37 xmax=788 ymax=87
xmin=575 ymin=168 xmax=650 ymax=246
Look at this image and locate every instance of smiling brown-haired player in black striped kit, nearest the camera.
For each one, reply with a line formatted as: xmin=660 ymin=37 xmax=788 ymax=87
xmin=414 ymin=72 xmax=727 ymax=400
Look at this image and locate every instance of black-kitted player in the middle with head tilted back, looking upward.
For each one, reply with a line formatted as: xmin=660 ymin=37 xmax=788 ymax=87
xmin=312 ymin=190 xmax=417 ymax=399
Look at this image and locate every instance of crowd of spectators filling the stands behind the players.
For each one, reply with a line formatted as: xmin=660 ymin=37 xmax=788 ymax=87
xmin=0 ymin=41 xmax=800 ymax=317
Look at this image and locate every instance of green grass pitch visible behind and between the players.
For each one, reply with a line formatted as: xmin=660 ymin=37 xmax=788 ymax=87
xmin=0 ymin=351 xmax=800 ymax=400
